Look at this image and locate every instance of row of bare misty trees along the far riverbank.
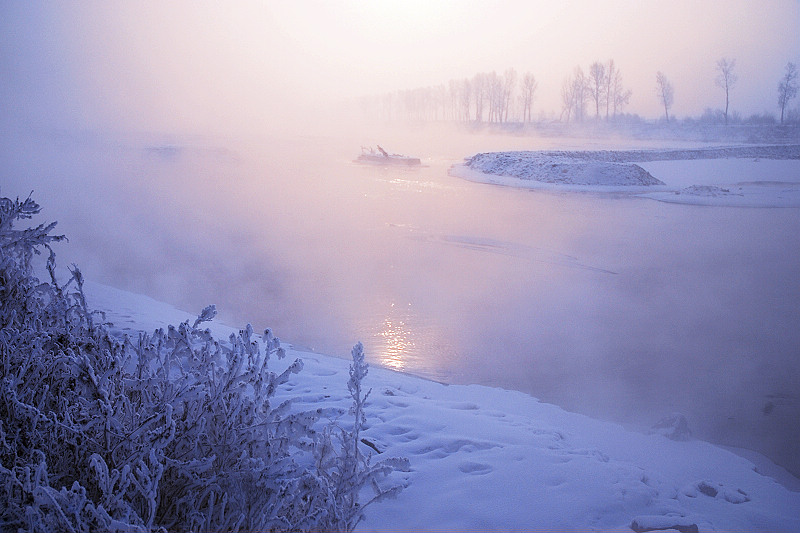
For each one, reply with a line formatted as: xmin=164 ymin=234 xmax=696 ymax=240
xmin=360 ymin=58 xmax=800 ymax=125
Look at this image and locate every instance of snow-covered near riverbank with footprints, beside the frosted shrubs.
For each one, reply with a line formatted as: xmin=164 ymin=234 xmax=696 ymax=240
xmin=86 ymin=282 xmax=800 ymax=531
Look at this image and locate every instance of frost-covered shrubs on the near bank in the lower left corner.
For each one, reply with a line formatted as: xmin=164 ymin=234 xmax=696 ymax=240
xmin=0 ymin=193 xmax=407 ymax=532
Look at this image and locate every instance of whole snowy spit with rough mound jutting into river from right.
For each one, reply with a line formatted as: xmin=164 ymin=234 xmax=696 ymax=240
xmin=450 ymin=145 xmax=800 ymax=207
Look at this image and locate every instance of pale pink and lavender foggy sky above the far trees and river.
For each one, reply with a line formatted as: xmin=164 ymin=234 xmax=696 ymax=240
xmin=0 ymin=0 xmax=800 ymax=132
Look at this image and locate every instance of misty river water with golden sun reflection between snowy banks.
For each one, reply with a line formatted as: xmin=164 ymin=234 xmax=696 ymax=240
xmin=6 ymin=128 xmax=800 ymax=474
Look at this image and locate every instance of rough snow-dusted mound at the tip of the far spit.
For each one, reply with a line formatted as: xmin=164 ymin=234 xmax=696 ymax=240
xmin=465 ymin=152 xmax=664 ymax=187
